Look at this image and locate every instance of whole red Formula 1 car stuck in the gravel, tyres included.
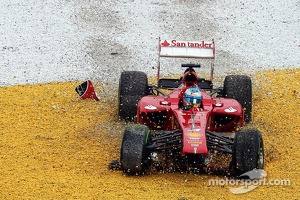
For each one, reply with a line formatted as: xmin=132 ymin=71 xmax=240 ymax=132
xmin=113 ymin=40 xmax=264 ymax=174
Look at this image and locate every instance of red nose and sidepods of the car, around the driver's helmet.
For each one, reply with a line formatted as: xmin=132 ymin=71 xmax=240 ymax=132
xmin=137 ymin=81 xmax=244 ymax=156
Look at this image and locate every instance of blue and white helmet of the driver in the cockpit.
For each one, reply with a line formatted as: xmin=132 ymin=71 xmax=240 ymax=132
xmin=183 ymin=87 xmax=202 ymax=108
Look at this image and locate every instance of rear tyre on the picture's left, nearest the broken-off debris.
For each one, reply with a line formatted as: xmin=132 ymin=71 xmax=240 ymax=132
xmin=118 ymin=71 xmax=148 ymax=121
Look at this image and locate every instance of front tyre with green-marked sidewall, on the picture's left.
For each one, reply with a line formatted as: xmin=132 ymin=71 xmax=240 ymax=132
xmin=121 ymin=124 xmax=151 ymax=175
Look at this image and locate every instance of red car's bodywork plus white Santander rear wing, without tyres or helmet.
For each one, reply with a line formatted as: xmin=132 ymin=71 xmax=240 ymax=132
xmin=137 ymin=39 xmax=244 ymax=156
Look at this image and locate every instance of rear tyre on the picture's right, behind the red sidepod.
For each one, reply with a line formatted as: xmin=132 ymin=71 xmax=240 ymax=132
xmin=223 ymin=75 xmax=252 ymax=123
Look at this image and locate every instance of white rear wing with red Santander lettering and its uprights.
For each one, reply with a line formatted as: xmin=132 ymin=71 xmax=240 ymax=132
xmin=157 ymin=38 xmax=215 ymax=81
